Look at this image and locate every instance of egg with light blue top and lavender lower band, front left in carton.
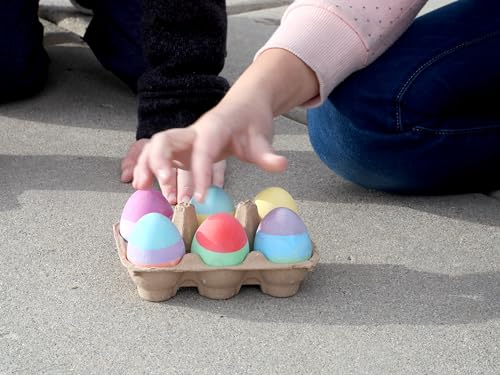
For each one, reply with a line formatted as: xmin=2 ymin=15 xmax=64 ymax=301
xmin=127 ymin=212 xmax=186 ymax=267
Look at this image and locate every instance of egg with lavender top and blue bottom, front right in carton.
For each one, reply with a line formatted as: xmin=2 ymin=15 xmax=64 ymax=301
xmin=254 ymin=207 xmax=312 ymax=263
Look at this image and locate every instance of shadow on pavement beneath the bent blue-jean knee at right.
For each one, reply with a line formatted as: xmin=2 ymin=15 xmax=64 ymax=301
xmin=227 ymin=151 xmax=500 ymax=227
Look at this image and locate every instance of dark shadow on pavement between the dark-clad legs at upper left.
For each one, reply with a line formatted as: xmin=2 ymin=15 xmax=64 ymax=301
xmin=0 ymin=44 xmax=137 ymax=131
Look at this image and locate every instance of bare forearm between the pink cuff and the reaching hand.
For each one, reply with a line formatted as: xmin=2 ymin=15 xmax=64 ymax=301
xmin=218 ymin=48 xmax=319 ymax=116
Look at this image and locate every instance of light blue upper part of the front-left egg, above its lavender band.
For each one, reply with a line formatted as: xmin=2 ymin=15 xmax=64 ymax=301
xmin=129 ymin=212 xmax=181 ymax=250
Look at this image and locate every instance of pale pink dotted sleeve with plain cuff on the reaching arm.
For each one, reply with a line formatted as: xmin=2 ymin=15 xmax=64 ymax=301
xmin=256 ymin=0 xmax=427 ymax=106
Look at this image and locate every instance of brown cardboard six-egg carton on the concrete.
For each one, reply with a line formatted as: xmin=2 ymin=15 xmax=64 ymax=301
xmin=113 ymin=201 xmax=319 ymax=302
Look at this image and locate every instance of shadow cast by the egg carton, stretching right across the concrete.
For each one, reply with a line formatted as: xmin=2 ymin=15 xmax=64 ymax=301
xmin=165 ymin=263 xmax=500 ymax=326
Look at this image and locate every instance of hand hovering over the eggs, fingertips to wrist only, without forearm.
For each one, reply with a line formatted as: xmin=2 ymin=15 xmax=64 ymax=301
xmin=133 ymin=97 xmax=287 ymax=200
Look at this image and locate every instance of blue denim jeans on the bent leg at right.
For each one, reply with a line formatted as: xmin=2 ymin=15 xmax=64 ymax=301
xmin=308 ymin=0 xmax=500 ymax=194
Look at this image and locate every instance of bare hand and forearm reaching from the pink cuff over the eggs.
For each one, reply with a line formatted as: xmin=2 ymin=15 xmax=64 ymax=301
xmin=133 ymin=49 xmax=319 ymax=201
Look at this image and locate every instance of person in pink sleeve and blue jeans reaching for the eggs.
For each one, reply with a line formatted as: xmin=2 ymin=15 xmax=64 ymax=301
xmin=133 ymin=0 xmax=500 ymax=200
